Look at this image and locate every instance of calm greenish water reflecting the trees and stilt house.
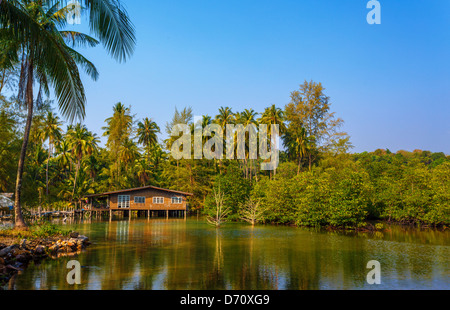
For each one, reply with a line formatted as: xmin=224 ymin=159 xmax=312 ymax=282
xmin=10 ymin=218 xmax=450 ymax=290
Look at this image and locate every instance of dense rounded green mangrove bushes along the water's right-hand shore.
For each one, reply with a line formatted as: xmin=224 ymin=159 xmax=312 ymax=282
xmin=252 ymin=151 xmax=450 ymax=228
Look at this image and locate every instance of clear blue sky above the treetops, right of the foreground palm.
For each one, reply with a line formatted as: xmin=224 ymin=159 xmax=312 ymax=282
xmin=72 ymin=0 xmax=450 ymax=154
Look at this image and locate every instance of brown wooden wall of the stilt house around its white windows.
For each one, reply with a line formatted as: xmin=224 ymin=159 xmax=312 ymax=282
xmin=108 ymin=189 xmax=187 ymax=211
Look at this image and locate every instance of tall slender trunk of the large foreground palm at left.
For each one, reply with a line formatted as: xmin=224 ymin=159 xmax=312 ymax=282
xmin=14 ymin=63 xmax=33 ymax=229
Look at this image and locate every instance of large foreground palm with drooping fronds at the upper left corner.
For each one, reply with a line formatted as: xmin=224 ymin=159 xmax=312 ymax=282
xmin=0 ymin=0 xmax=135 ymax=228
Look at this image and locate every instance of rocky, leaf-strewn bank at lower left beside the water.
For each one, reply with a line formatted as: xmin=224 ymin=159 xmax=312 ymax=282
xmin=0 ymin=225 xmax=90 ymax=290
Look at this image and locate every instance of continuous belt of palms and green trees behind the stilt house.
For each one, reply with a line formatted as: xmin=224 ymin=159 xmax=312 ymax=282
xmin=0 ymin=82 xmax=450 ymax=228
